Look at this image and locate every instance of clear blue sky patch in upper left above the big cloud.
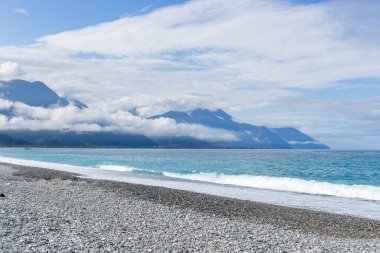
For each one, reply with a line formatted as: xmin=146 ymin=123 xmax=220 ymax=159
xmin=0 ymin=0 xmax=189 ymax=45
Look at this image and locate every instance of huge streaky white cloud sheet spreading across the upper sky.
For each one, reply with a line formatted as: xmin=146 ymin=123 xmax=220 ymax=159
xmin=0 ymin=0 xmax=380 ymax=100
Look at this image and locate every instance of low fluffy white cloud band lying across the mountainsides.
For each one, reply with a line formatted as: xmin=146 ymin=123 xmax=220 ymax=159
xmin=0 ymin=99 xmax=238 ymax=141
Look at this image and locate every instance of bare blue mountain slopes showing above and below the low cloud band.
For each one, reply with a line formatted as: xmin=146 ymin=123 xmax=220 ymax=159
xmin=0 ymin=80 xmax=329 ymax=149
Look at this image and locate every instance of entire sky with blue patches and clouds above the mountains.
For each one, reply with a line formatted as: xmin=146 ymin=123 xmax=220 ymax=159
xmin=0 ymin=0 xmax=380 ymax=149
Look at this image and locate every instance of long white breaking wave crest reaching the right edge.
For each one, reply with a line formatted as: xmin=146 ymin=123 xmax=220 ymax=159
xmin=163 ymin=172 xmax=380 ymax=201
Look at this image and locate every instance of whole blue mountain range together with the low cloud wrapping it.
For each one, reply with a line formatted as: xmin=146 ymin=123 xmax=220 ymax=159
xmin=0 ymin=80 xmax=327 ymax=148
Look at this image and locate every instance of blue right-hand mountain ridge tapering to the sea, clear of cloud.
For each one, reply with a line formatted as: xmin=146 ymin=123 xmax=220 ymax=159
xmin=150 ymin=108 xmax=328 ymax=149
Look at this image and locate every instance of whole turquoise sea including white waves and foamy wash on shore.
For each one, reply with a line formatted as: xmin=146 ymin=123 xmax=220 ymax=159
xmin=0 ymin=148 xmax=380 ymax=220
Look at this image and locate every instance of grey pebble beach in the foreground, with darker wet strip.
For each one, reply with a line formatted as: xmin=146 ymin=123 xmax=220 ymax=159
xmin=0 ymin=164 xmax=380 ymax=252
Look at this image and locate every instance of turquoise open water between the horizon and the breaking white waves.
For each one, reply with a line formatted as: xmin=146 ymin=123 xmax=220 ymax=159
xmin=0 ymin=148 xmax=380 ymax=186
